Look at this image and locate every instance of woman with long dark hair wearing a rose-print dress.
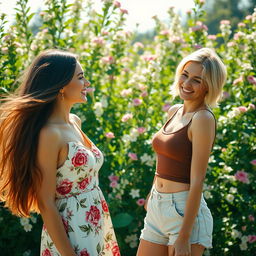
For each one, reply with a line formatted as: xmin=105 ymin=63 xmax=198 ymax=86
xmin=0 ymin=50 xmax=120 ymax=256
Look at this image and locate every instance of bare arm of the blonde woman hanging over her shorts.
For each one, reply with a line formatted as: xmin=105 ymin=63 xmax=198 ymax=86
xmin=175 ymin=110 xmax=215 ymax=255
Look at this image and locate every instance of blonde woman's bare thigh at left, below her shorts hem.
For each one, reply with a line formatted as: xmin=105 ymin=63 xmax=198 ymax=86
xmin=137 ymin=239 xmax=168 ymax=256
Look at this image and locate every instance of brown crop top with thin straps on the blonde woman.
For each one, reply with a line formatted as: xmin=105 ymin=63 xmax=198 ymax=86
xmin=152 ymin=108 xmax=216 ymax=184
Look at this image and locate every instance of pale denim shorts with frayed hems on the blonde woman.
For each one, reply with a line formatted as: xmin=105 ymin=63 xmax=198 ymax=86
xmin=140 ymin=187 xmax=213 ymax=248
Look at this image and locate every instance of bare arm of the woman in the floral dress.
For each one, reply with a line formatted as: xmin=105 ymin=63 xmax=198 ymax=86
xmin=37 ymin=127 xmax=76 ymax=256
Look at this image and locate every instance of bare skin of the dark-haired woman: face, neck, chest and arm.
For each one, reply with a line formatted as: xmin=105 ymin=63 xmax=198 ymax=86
xmin=37 ymin=63 xmax=90 ymax=256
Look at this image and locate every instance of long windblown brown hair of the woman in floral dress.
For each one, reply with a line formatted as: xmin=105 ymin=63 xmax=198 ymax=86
xmin=0 ymin=50 xmax=77 ymax=217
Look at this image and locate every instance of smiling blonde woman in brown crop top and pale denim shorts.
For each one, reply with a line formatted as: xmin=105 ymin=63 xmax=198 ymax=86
xmin=137 ymin=48 xmax=226 ymax=256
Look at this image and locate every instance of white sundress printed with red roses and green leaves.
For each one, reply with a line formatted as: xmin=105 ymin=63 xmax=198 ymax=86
xmin=41 ymin=142 xmax=120 ymax=256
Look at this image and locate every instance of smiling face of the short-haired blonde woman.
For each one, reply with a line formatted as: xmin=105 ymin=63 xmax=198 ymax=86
xmin=179 ymin=61 xmax=207 ymax=103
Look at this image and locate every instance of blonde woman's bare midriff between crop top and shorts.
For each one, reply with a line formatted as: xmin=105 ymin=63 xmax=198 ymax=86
xmin=154 ymin=176 xmax=190 ymax=193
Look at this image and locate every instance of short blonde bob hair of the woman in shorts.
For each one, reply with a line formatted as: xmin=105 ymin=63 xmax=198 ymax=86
xmin=172 ymin=48 xmax=227 ymax=107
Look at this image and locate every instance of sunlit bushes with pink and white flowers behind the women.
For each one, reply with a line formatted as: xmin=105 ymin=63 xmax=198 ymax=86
xmin=0 ymin=0 xmax=256 ymax=256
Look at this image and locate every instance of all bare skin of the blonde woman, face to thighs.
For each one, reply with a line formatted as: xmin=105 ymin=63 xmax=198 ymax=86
xmin=137 ymin=62 xmax=215 ymax=256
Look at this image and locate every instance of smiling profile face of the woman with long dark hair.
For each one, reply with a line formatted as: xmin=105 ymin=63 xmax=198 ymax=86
xmin=61 ymin=62 xmax=90 ymax=104
